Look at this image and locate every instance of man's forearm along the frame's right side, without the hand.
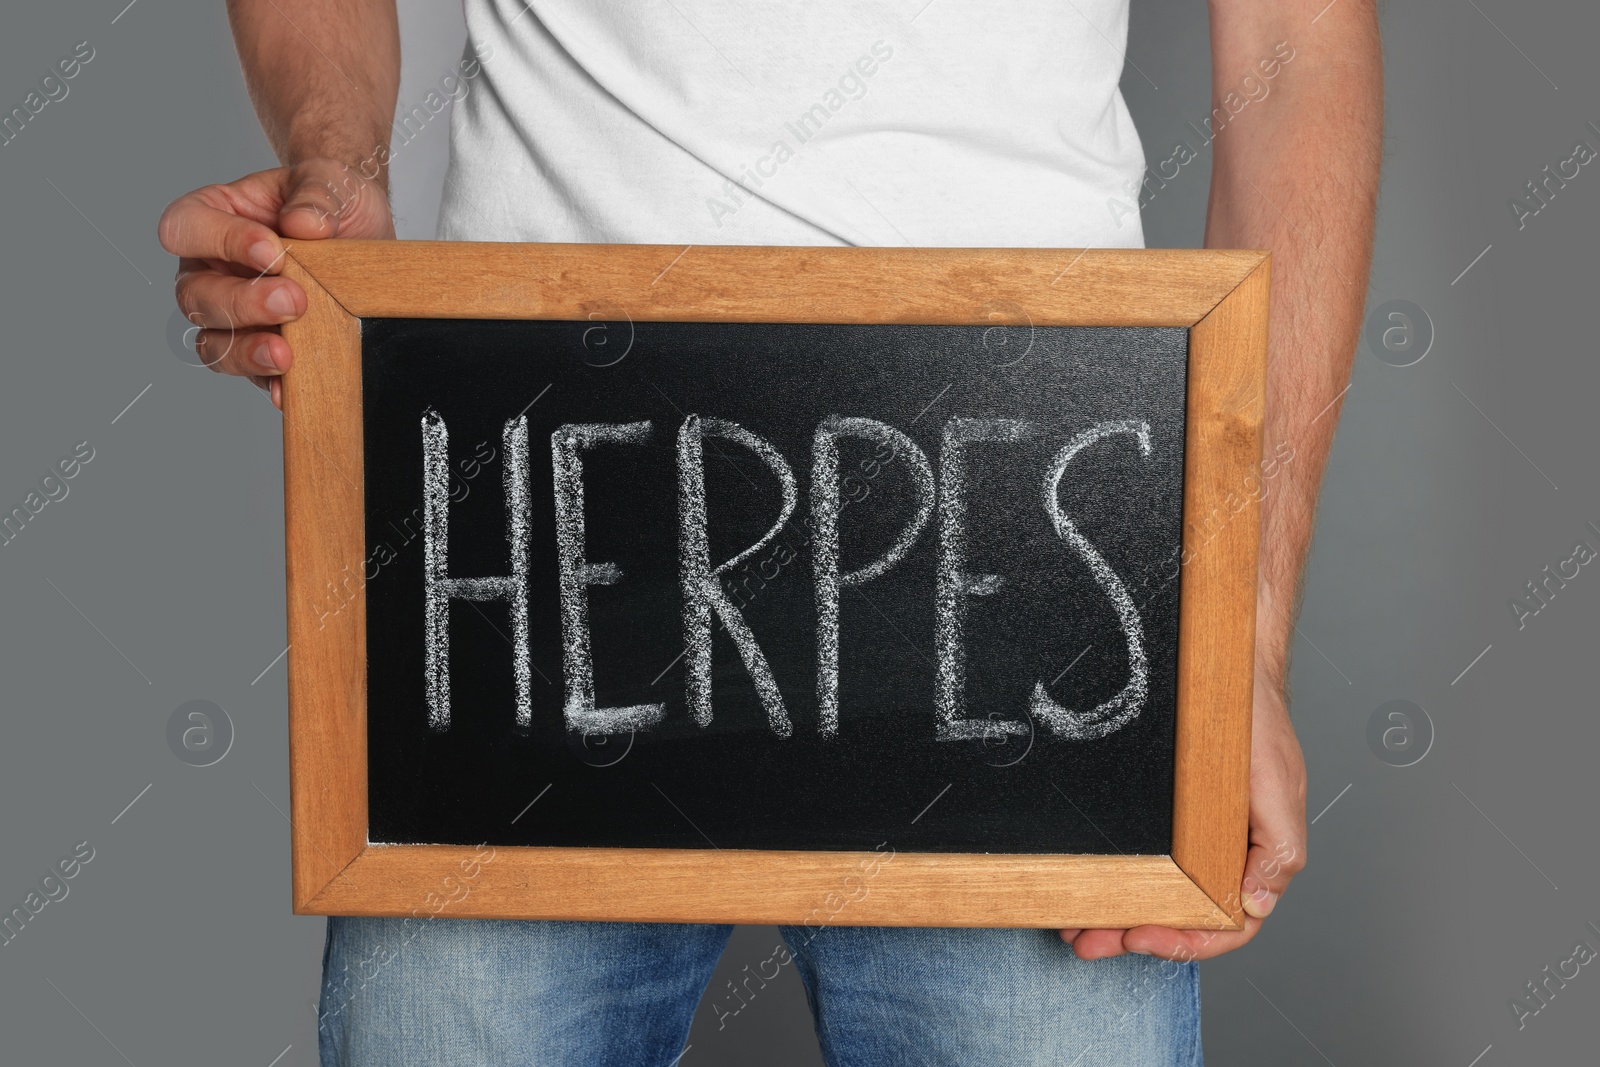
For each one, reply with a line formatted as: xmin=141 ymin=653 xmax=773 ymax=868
xmin=1205 ymin=0 xmax=1382 ymax=686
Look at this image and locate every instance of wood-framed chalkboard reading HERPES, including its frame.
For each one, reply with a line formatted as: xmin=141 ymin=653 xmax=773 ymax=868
xmin=285 ymin=242 xmax=1266 ymax=928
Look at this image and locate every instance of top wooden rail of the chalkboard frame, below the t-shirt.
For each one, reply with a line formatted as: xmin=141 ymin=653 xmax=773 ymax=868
xmin=288 ymin=242 xmax=1261 ymax=326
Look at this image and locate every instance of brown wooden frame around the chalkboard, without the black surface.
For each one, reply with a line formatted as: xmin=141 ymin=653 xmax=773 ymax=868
xmin=283 ymin=240 xmax=1269 ymax=929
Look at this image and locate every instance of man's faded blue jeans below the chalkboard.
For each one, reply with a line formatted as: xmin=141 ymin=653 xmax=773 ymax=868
xmin=318 ymin=918 xmax=1200 ymax=1067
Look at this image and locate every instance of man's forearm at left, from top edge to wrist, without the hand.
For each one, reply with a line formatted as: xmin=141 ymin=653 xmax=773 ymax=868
xmin=227 ymin=0 xmax=400 ymax=189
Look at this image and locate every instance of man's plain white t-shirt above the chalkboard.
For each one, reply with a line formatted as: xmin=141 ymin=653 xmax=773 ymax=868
xmin=438 ymin=0 xmax=1144 ymax=248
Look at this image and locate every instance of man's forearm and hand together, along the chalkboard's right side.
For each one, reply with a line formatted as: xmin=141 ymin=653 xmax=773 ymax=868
xmin=1062 ymin=0 xmax=1384 ymax=960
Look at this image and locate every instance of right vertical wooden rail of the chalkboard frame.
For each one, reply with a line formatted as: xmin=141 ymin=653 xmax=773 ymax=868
xmin=1173 ymin=261 xmax=1270 ymax=921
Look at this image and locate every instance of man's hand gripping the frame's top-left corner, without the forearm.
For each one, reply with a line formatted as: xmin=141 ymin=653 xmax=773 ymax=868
xmin=157 ymin=160 xmax=395 ymax=408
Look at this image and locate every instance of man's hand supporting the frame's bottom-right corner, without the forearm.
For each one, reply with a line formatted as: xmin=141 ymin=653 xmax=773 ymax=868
xmin=1061 ymin=664 xmax=1306 ymax=961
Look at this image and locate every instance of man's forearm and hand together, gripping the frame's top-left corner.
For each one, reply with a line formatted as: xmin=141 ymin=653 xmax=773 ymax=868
xmin=160 ymin=0 xmax=400 ymax=408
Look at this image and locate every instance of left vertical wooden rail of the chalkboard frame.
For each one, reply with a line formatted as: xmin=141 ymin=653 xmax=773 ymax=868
xmin=283 ymin=258 xmax=366 ymax=904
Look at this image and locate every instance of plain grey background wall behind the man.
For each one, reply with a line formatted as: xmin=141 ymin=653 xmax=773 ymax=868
xmin=0 ymin=0 xmax=1600 ymax=1067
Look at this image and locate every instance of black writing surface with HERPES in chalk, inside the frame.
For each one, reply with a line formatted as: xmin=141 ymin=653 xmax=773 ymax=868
xmin=360 ymin=317 xmax=1189 ymax=856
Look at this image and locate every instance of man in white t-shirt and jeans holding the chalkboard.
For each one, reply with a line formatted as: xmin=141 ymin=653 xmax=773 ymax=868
xmin=160 ymin=0 xmax=1382 ymax=1067
